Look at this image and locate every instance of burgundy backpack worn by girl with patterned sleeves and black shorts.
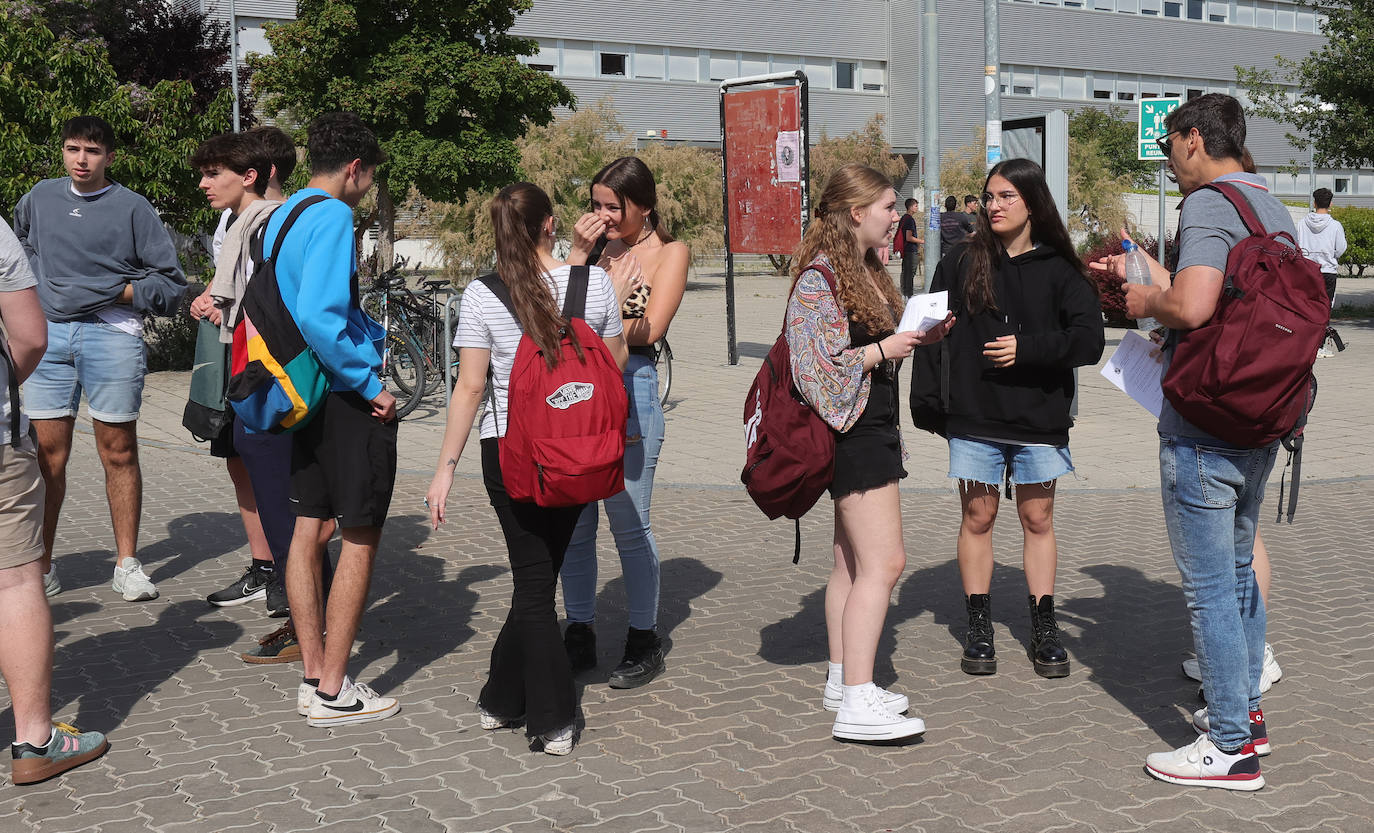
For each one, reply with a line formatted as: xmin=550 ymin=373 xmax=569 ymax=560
xmin=739 ymin=263 xmax=840 ymax=564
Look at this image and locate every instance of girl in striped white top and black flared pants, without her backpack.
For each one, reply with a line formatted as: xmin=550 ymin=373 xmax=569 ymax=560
xmin=425 ymin=183 xmax=635 ymax=755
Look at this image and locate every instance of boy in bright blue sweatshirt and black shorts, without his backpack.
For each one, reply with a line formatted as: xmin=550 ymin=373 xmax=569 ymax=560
xmin=262 ymin=113 xmax=400 ymax=726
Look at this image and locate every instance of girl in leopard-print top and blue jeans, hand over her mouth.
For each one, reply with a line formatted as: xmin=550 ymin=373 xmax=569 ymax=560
xmin=557 ymin=157 xmax=690 ymax=689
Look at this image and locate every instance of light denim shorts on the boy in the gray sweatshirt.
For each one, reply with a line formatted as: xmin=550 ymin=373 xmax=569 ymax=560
xmin=23 ymin=320 xmax=147 ymax=423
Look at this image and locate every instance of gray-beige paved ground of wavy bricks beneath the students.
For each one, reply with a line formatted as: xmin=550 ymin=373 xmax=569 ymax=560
xmin=0 ymin=275 xmax=1374 ymax=833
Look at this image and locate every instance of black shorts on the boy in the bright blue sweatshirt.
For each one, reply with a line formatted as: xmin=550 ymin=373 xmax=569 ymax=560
xmin=291 ymin=392 xmax=397 ymax=529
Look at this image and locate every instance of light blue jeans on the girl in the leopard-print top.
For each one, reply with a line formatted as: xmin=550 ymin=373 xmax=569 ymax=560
xmin=562 ymin=355 xmax=664 ymax=631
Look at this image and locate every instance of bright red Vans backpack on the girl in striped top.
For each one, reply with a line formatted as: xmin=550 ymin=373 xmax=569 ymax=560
xmin=478 ymin=267 xmax=629 ymax=506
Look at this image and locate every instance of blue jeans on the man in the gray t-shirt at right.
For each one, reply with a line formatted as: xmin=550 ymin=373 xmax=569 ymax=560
xmin=1160 ymin=433 xmax=1278 ymax=751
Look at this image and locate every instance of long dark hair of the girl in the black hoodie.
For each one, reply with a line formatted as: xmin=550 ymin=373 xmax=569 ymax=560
xmin=963 ymin=159 xmax=1098 ymax=312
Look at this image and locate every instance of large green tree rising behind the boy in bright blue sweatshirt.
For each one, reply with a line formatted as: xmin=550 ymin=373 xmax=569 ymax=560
xmin=250 ymin=0 xmax=573 ymax=270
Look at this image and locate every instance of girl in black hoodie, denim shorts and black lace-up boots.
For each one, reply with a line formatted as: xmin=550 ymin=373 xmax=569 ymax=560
xmin=911 ymin=159 xmax=1103 ymax=678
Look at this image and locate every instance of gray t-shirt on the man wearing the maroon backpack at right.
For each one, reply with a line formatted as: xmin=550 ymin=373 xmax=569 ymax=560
xmin=1160 ymin=173 xmax=1297 ymax=443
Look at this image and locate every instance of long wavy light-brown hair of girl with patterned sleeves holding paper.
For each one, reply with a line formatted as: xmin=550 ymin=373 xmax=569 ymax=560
xmin=791 ymin=162 xmax=901 ymax=335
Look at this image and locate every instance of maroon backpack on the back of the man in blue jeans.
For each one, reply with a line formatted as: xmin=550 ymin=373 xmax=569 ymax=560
xmin=1162 ymin=183 xmax=1331 ymax=448
